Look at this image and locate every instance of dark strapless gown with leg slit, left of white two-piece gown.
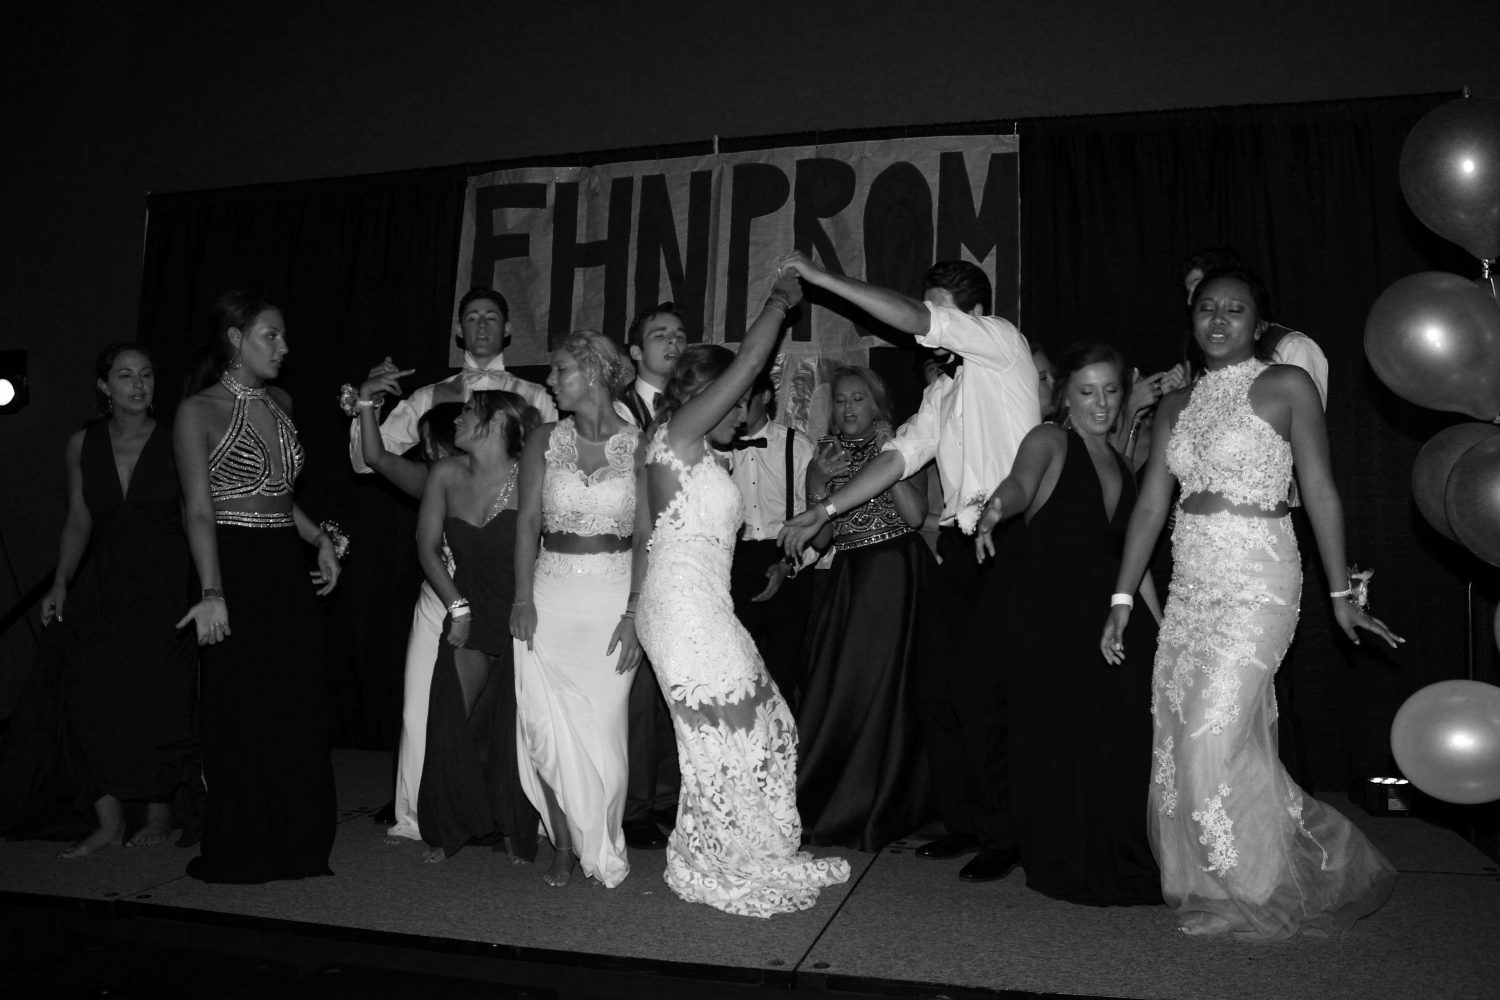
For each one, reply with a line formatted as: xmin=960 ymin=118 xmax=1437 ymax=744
xmin=417 ymin=510 xmax=540 ymax=861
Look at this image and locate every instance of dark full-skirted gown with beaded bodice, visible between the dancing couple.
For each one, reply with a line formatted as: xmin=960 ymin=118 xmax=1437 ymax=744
xmin=797 ymin=444 xmax=936 ymax=850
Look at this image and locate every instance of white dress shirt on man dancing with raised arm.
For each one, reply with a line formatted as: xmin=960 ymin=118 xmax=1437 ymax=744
xmin=885 ymin=303 xmax=1041 ymax=534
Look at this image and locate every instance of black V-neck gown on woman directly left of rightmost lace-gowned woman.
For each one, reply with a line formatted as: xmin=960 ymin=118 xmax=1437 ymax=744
xmin=1002 ymin=430 xmax=1161 ymax=906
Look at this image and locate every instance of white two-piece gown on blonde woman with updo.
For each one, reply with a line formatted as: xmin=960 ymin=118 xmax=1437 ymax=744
xmin=515 ymin=417 xmax=641 ymax=888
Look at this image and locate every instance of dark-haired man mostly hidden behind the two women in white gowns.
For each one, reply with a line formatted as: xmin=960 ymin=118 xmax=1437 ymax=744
xmin=621 ymin=301 xmax=687 ymax=849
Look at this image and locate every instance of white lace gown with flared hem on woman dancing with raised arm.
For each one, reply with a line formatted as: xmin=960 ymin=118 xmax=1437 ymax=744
xmin=636 ymin=426 xmax=849 ymax=916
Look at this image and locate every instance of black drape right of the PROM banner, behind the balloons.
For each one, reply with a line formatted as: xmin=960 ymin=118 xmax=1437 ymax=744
xmin=1020 ymin=96 xmax=1482 ymax=789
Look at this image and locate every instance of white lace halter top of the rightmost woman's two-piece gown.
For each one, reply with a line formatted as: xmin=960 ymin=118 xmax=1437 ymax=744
xmin=1167 ymin=360 xmax=1292 ymax=510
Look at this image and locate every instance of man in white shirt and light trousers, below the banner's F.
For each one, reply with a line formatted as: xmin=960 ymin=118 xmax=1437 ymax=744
xmin=350 ymin=288 xmax=558 ymax=840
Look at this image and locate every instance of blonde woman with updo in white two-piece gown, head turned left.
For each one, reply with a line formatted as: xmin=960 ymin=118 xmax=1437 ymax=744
xmin=510 ymin=331 xmax=645 ymax=888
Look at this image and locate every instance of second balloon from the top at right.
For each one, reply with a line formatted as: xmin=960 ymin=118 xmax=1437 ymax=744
xmin=1365 ymin=271 xmax=1500 ymax=420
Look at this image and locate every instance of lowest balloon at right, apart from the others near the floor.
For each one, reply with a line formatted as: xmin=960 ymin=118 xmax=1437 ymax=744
xmin=1391 ymin=681 xmax=1500 ymax=804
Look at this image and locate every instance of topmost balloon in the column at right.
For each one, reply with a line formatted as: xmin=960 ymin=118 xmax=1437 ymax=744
xmin=1401 ymin=97 xmax=1500 ymax=261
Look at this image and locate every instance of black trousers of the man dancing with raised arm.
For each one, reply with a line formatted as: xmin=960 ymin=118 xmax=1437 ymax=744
xmin=918 ymin=528 xmax=1016 ymax=849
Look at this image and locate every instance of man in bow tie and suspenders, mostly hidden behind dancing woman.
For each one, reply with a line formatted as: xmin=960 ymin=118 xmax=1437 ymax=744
xmin=729 ymin=372 xmax=813 ymax=711
